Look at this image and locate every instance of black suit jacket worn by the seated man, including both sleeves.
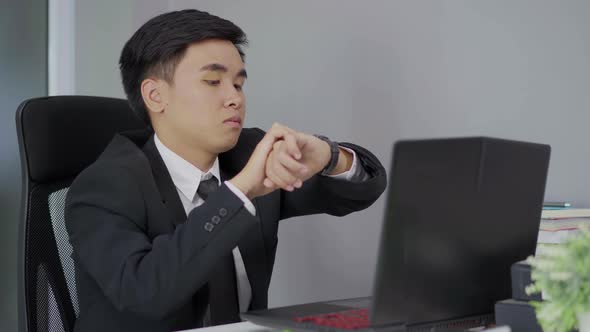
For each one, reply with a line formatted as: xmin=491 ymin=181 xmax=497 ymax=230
xmin=65 ymin=129 xmax=386 ymax=332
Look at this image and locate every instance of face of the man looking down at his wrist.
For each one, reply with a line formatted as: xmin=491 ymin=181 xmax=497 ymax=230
xmin=158 ymin=40 xmax=246 ymax=154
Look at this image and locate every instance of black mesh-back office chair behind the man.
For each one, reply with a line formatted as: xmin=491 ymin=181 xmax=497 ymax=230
xmin=16 ymin=96 xmax=145 ymax=332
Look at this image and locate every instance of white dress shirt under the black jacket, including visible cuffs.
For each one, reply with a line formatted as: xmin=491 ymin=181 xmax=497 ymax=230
xmin=154 ymin=135 xmax=366 ymax=312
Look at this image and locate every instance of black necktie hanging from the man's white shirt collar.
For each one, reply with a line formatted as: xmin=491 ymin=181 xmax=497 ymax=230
xmin=197 ymin=176 xmax=240 ymax=326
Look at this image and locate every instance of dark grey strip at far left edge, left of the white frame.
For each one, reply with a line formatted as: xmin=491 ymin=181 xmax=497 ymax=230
xmin=0 ymin=0 xmax=47 ymax=331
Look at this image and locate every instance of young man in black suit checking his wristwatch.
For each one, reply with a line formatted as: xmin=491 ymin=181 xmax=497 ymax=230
xmin=66 ymin=10 xmax=386 ymax=332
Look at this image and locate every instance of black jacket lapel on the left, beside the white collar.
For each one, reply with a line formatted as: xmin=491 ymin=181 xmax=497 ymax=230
xmin=143 ymin=135 xmax=187 ymax=225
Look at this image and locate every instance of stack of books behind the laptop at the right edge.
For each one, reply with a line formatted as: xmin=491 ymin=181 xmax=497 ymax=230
xmin=537 ymin=202 xmax=590 ymax=244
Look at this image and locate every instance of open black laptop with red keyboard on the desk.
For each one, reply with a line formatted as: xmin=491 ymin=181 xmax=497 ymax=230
xmin=242 ymin=137 xmax=550 ymax=331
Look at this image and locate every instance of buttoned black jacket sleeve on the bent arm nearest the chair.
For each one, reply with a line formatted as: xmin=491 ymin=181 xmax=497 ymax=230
xmin=65 ymin=163 xmax=257 ymax=318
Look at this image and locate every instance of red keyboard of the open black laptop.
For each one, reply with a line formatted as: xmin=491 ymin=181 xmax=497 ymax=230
xmin=294 ymin=309 xmax=369 ymax=330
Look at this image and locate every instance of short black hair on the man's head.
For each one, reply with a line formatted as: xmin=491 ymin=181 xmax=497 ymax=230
xmin=119 ymin=9 xmax=248 ymax=127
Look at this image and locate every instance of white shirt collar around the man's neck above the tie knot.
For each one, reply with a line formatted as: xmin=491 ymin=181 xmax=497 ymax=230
xmin=154 ymin=134 xmax=221 ymax=202
